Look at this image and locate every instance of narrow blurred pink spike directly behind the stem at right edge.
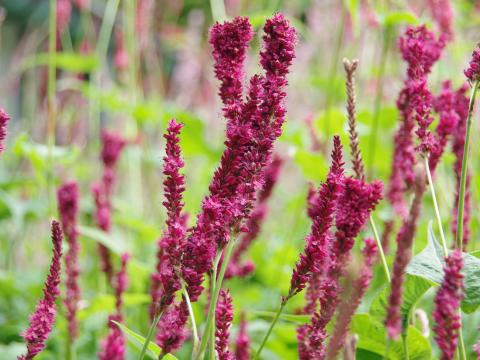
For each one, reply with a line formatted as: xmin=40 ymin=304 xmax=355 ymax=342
xmin=451 ymin=84 xmax=472 ymax=246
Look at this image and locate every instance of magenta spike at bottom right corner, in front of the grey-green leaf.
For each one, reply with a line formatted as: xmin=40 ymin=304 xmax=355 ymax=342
xmin=433 ymin=249 xmax=463 ymax=360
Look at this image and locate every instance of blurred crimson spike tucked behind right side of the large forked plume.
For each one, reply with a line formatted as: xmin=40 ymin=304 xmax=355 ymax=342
xmin=225 ymin=155 xmax=283 ymax=279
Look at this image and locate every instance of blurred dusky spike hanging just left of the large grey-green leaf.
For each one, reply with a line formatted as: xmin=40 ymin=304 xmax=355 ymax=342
xmin=385 ymin=173 xmax=426 ymax=339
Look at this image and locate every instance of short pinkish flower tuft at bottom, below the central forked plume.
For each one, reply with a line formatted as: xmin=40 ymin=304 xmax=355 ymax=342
xmin=156 ymin=300 xmax=188 ymax=354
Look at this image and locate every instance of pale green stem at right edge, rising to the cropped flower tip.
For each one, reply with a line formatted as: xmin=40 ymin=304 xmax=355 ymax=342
xmin=455 ymin=80 xmax=480 ymax=250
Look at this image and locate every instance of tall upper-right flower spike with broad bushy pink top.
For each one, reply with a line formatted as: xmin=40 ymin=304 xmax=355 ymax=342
xmin=387 ymin=26 xmax=444 ymax=218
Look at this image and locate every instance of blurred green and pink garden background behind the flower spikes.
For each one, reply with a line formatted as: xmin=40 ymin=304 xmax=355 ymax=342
xmin=0 ymin=0 xmax=480 ymax=359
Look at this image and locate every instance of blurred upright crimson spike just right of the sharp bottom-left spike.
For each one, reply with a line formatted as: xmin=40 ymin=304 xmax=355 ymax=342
xmin=57 ymin=181 xmax=80 ymax=340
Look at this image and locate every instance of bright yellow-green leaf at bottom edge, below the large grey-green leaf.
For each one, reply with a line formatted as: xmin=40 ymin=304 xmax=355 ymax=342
xmin=350 ymin=314 xmax=432 ymax=360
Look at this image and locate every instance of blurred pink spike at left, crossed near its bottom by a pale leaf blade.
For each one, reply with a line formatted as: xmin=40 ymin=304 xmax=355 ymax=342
xmin=92 ymin=130 xmax=126 ymax=282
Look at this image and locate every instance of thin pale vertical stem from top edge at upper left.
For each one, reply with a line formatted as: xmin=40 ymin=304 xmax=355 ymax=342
xmin=47 ymin=0 xmax=57 ymax=215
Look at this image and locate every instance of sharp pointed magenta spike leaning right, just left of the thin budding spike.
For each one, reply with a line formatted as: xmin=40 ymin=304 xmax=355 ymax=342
xmin=288 ymin=136 xmax=344 ymax=297
